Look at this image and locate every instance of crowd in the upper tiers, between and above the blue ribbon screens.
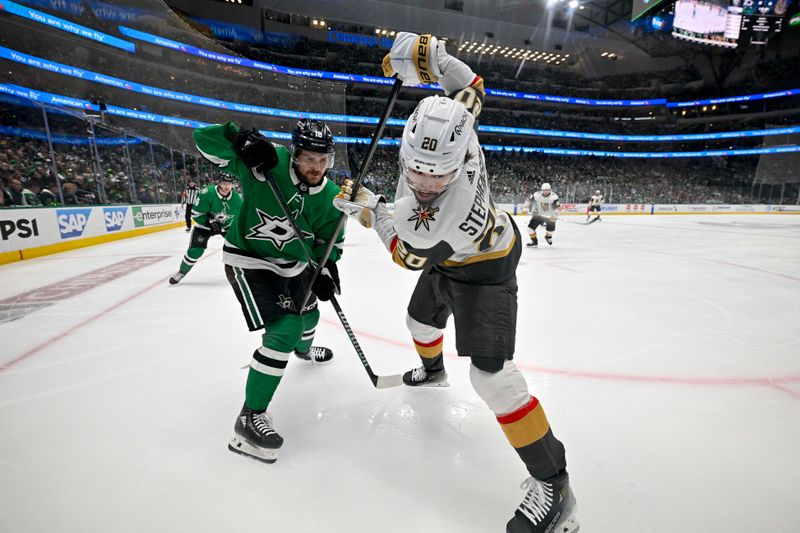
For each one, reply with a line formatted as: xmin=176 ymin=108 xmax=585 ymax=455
xmin=0 ymin=6 xmax=800 ymax=149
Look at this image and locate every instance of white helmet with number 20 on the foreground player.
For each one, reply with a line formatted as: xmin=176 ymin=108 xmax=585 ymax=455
xmin=400 ymin=96 xmax=475 ymax=202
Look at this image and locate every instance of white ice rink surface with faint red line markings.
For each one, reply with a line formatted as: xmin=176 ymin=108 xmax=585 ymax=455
xmin=0 ymin=215 xmax=800 ymax=533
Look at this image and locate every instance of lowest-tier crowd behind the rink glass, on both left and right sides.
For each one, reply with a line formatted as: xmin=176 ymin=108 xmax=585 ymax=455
xmin=0 ymin=126 xmax=796 ymax=207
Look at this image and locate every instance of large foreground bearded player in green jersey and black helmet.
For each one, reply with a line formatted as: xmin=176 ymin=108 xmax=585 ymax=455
xmin=194 ymin=119 xmax=344 ymax=463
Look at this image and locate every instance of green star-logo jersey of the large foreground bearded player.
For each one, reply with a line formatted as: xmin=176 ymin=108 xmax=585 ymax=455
xmin=193 ymin=122 xmax=344 ymax=277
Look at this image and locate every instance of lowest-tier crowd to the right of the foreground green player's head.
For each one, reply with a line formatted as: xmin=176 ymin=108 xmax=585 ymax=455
xmin=350 ymin=145 xmax=797 ymax=204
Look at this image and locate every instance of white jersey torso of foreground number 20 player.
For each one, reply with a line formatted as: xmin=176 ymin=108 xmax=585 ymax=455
xmin=391 ymin=131 xmax=518 ymax=284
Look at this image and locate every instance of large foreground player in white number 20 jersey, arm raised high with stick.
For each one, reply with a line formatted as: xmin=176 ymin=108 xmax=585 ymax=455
xmin=334 ymin=32 xmax=578 ymax=533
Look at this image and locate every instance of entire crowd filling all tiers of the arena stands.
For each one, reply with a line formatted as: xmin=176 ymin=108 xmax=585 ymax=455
xmin=0 ymin=2 xmax=800 ymax=210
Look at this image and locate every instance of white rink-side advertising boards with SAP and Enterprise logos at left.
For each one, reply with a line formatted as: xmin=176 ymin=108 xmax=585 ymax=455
xmin=0 ymin=204 xmax=183 ymax=253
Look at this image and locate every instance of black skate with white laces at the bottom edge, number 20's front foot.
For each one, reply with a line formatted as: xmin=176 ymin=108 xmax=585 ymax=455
xmin=506 ymin=474 xmax=580 ymax=533
